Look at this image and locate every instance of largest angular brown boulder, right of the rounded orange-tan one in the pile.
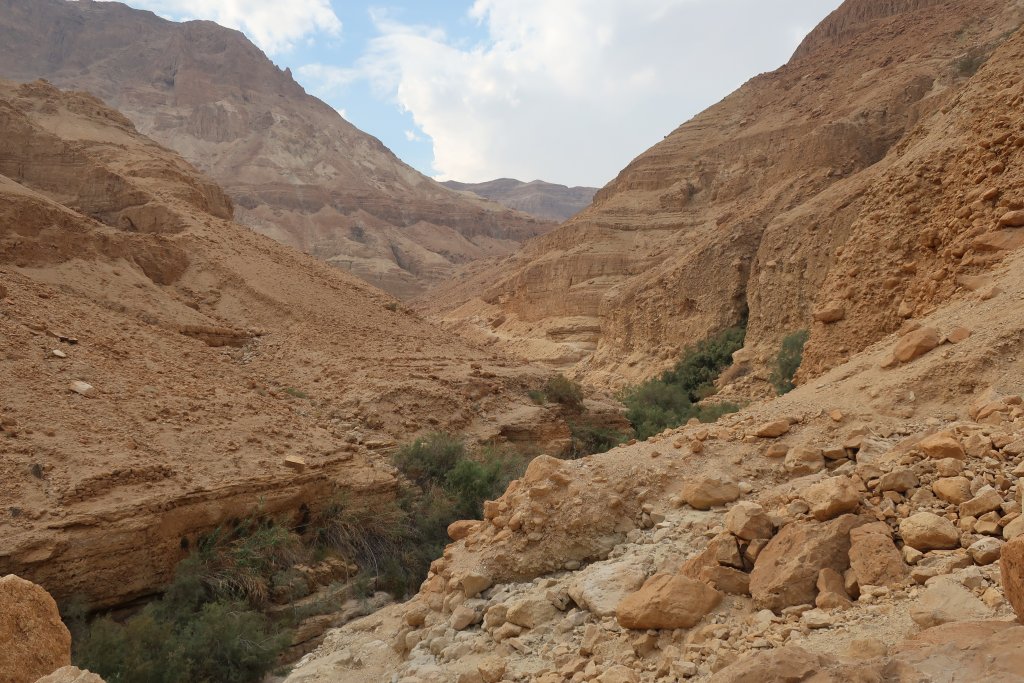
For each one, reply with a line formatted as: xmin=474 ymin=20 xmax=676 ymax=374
xmin=751 ymin=515 xmax=865 ymax=609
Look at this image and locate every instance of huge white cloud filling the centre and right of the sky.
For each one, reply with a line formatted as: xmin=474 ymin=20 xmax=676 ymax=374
xmin=304 ymin=0 xmax=840 ymax=184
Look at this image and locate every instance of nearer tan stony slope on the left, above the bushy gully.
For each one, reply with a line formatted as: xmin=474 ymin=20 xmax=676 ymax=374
xmin=0 ymin=82 xmax=567 ymax=607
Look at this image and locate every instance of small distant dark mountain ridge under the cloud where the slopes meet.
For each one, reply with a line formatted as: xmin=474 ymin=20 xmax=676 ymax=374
xmin=441 ymin=178 xmax=597 ymax=222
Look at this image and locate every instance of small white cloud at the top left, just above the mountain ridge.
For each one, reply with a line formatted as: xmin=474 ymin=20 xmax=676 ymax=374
xmin=114 ymin=0 xmax=341 ymax=54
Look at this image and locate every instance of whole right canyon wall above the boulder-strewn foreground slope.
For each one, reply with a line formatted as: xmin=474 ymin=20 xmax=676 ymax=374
xmin=422 ymin=0 xmax=1024 ymax=393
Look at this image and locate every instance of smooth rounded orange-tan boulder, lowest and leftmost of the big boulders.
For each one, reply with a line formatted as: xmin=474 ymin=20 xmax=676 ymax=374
xmin=615 ymin=573 xmax=722 ymax=630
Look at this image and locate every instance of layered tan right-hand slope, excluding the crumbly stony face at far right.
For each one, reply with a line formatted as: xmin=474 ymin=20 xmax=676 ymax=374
xmin=423 ymin=0 xmax=1022 ymax=393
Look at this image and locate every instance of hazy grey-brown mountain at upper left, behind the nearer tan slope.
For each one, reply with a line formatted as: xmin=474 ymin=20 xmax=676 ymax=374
xmin=0 ymin=0 xmax=551 ymax=296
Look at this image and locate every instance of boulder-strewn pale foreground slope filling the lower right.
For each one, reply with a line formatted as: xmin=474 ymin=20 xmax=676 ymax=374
xmin=288 ymin=231 xmax=1024 ymax=683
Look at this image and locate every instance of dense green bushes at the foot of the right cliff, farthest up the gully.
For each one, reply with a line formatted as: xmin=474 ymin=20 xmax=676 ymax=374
xmin=621 ymin=327 xmax=746 ymax=439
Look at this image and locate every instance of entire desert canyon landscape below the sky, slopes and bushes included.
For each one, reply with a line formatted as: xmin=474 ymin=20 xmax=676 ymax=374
xmin=0 ymin=0 xmax=1024 ymax=683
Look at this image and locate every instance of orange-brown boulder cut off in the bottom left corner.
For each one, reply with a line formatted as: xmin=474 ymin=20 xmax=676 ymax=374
xmin=0 ymin=574 xmax=71 ymax=683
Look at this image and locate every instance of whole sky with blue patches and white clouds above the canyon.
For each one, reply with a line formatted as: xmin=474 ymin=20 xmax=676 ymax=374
xmin=108 ymin=0 xmax=841 ymax=186
